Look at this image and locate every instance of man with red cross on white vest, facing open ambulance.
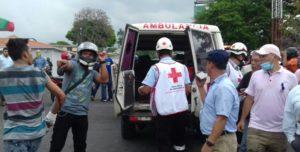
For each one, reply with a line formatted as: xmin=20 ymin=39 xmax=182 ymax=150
xmin=138 ymin=37 xmax=190 ymax=152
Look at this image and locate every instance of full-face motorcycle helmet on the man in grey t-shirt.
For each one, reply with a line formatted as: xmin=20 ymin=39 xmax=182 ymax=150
xmin=77 ymin=42 xmax=98 ymax=69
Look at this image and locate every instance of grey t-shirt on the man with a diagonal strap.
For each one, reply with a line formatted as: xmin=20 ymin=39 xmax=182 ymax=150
xmin=61 ymin=60 xmax=99 ymax=115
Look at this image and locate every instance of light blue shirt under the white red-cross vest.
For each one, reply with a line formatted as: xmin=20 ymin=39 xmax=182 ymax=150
xmin=142 ymin=57 xmax=190 ymax=87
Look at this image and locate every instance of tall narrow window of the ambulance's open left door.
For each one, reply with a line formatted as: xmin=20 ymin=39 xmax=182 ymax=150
xmin=122 ymin=29 xmax=138 ymax=71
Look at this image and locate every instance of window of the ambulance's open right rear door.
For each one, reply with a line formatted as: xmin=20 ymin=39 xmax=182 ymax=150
xmin=192 ymin=30 xmax=214 ymax=71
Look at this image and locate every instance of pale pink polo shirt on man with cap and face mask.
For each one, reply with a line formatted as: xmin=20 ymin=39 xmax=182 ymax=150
xmin=245 ymin=67 xmax=297 ymax=132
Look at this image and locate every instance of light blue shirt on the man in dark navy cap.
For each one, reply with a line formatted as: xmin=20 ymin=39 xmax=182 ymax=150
xmin=200 ymin=73 xmax=240 ymax=135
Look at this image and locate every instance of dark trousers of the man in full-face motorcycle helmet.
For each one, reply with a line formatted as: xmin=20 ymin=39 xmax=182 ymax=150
xmin=50 ymin=111 xmax=88 ymax=152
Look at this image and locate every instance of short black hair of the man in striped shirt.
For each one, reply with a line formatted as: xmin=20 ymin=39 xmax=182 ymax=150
xmin=6 ymin=38 xmax=28 ymax=61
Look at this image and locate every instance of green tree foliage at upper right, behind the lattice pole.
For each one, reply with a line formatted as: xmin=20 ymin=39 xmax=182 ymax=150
xmin=196 ymin=0 xmax=300 ymax=49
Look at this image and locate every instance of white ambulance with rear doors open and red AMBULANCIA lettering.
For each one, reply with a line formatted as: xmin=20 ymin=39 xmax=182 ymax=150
xmin=113 ymin=23 xmax=224 ymax=139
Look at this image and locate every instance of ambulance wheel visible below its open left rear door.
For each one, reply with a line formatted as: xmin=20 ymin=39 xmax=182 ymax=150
xmin=121 ymin=116 xmax=136 ymax=139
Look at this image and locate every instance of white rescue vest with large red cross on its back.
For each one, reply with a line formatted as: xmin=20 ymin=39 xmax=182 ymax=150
xmin=151 ymin=62 xmax=188 ymax=116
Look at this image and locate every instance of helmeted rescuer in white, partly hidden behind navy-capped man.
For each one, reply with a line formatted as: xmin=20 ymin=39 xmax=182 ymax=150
xmin=226 ymin=42 xmax=247 ymax=87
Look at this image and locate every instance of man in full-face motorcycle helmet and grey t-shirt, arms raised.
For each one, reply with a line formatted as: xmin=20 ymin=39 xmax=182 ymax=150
xmin=50 ymin=42 xmax=108 ymax=152
